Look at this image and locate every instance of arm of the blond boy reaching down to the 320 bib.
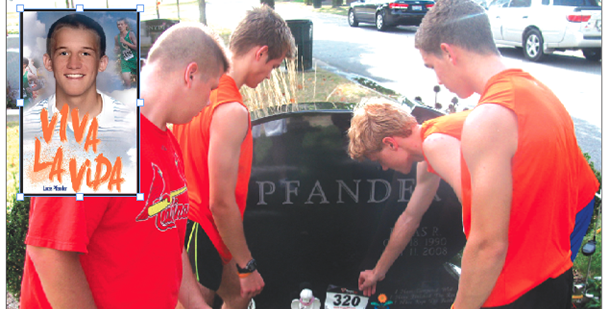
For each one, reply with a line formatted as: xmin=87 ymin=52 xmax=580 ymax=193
xmin=358 ymin=161 xmax=440 ymax=296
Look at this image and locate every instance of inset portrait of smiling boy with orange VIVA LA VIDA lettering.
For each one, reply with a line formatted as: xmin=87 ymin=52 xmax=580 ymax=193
xmin=20 ymin=10 xmax=139 ymax=195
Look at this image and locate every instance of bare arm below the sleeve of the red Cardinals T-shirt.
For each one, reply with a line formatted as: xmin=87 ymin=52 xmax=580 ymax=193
xmin=27 ymin=245 xmax=96 ymax=309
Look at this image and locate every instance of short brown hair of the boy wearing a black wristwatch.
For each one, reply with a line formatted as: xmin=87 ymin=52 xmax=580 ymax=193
xmin=229 ymin=5 xmax=296 ymax=61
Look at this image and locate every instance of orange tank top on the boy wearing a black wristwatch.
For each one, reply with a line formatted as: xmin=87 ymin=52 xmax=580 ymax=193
xmin=172 ymin=74 xmax=253 ymax=264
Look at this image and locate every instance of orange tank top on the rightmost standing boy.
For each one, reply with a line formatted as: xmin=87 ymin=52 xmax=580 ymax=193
xmin=462 ymin=69 xmax=599 ymax=307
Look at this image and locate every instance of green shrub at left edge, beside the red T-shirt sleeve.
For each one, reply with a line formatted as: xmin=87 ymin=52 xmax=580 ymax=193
xmin=6 ymin=178 xmax=30 ymax=300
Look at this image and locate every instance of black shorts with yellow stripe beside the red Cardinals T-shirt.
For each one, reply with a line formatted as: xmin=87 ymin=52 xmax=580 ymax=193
xmin=184 ymin=220 xmax=223 ymax=291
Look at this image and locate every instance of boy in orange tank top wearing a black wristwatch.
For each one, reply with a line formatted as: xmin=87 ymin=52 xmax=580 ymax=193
xmin=173 ymin=6 xmax=295 ymax=309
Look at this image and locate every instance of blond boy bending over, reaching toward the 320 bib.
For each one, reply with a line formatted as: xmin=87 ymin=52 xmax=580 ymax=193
xmin=348 ymin=102 xmax=469 ymax=296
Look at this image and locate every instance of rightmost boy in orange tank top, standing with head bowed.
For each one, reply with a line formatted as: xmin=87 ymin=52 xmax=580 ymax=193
xmin=415 ymin=0 xmax=599 ymax=309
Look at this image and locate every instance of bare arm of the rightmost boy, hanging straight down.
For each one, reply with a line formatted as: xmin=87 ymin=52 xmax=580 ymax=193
xmin=454 ymin=104 xmax=518 ymax=309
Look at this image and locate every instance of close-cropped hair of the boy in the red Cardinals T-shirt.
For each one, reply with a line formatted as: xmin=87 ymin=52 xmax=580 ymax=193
xmin=146 ymin=22 xmax=229 ymax=78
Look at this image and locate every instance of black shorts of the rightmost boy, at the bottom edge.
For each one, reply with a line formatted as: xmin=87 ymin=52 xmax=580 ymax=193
xmin=485 ymin=268 xmax=574 ymax=309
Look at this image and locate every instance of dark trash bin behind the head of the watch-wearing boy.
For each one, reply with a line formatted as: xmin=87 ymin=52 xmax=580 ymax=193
xmin=286 ymin=19 xmax=315 ymax=71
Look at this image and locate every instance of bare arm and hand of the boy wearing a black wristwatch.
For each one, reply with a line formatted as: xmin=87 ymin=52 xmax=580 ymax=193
xmin=208 ymin=102 xmax=264 ymax=297
